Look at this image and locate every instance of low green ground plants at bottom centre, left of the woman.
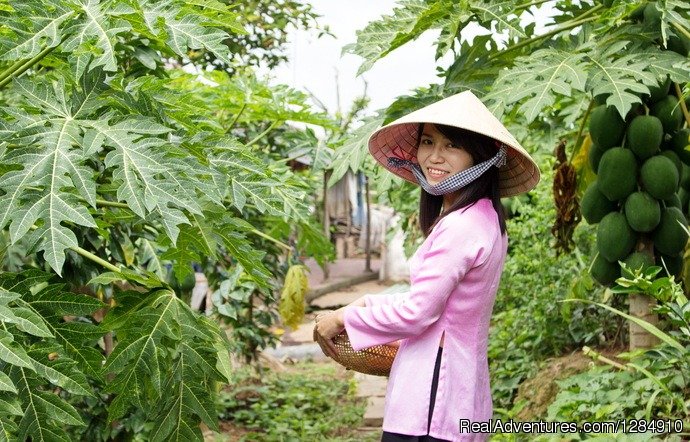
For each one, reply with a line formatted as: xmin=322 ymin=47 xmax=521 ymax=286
xmin=216 ymin=363 xmax=364 ymax=441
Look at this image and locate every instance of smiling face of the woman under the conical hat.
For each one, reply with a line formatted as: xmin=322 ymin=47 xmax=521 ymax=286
xmin=417 ymin=124 xmax=474 ymax=185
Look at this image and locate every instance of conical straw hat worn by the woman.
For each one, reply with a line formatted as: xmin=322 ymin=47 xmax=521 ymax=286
xmin=369 ymin=91 xmax=539 ymax=197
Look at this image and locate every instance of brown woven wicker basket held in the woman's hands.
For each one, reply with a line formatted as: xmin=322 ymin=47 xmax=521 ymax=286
xmin=314 ymin=328 xmax=398 ymax=376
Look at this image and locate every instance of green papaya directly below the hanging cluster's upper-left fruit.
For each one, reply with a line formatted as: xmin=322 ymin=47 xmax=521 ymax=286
xmin=597 ymin=147 xmax=636 ymax=201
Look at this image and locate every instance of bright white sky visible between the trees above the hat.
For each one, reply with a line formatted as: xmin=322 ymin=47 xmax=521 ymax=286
xmin=263 ymin=0 xmax=450 ymax=114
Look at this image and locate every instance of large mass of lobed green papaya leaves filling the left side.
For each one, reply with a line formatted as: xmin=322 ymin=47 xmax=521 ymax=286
xmin=0 ymin=0 xmax=331 ymax=440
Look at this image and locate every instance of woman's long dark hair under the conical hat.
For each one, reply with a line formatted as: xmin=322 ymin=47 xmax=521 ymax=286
xmin=417 ymin=123 xmax=506 ymax=237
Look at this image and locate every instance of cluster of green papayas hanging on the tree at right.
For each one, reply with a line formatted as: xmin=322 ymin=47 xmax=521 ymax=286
xmin=581 ymin=79 xmax=690 ymax=285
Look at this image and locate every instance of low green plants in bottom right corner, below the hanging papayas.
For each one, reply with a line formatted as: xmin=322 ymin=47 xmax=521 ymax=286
xmin=548 ymin=267 xmax=690 ymax=426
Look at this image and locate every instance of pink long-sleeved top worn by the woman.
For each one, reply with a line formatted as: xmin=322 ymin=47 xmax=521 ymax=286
xmin=343 ymin=198 xmax=508 ymax=441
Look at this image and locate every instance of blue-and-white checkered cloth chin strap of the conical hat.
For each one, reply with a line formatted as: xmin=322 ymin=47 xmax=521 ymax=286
xmin=388 ymin=146 xmax=506 ymax=195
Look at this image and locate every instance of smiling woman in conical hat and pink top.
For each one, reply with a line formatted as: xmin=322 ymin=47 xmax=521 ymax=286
xmin=316 ymin=91 xmax=539 ymax=441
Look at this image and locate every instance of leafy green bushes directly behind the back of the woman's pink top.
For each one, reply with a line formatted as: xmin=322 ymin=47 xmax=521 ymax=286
xmin=488 ymin=162 xmax=618 ymax=409
